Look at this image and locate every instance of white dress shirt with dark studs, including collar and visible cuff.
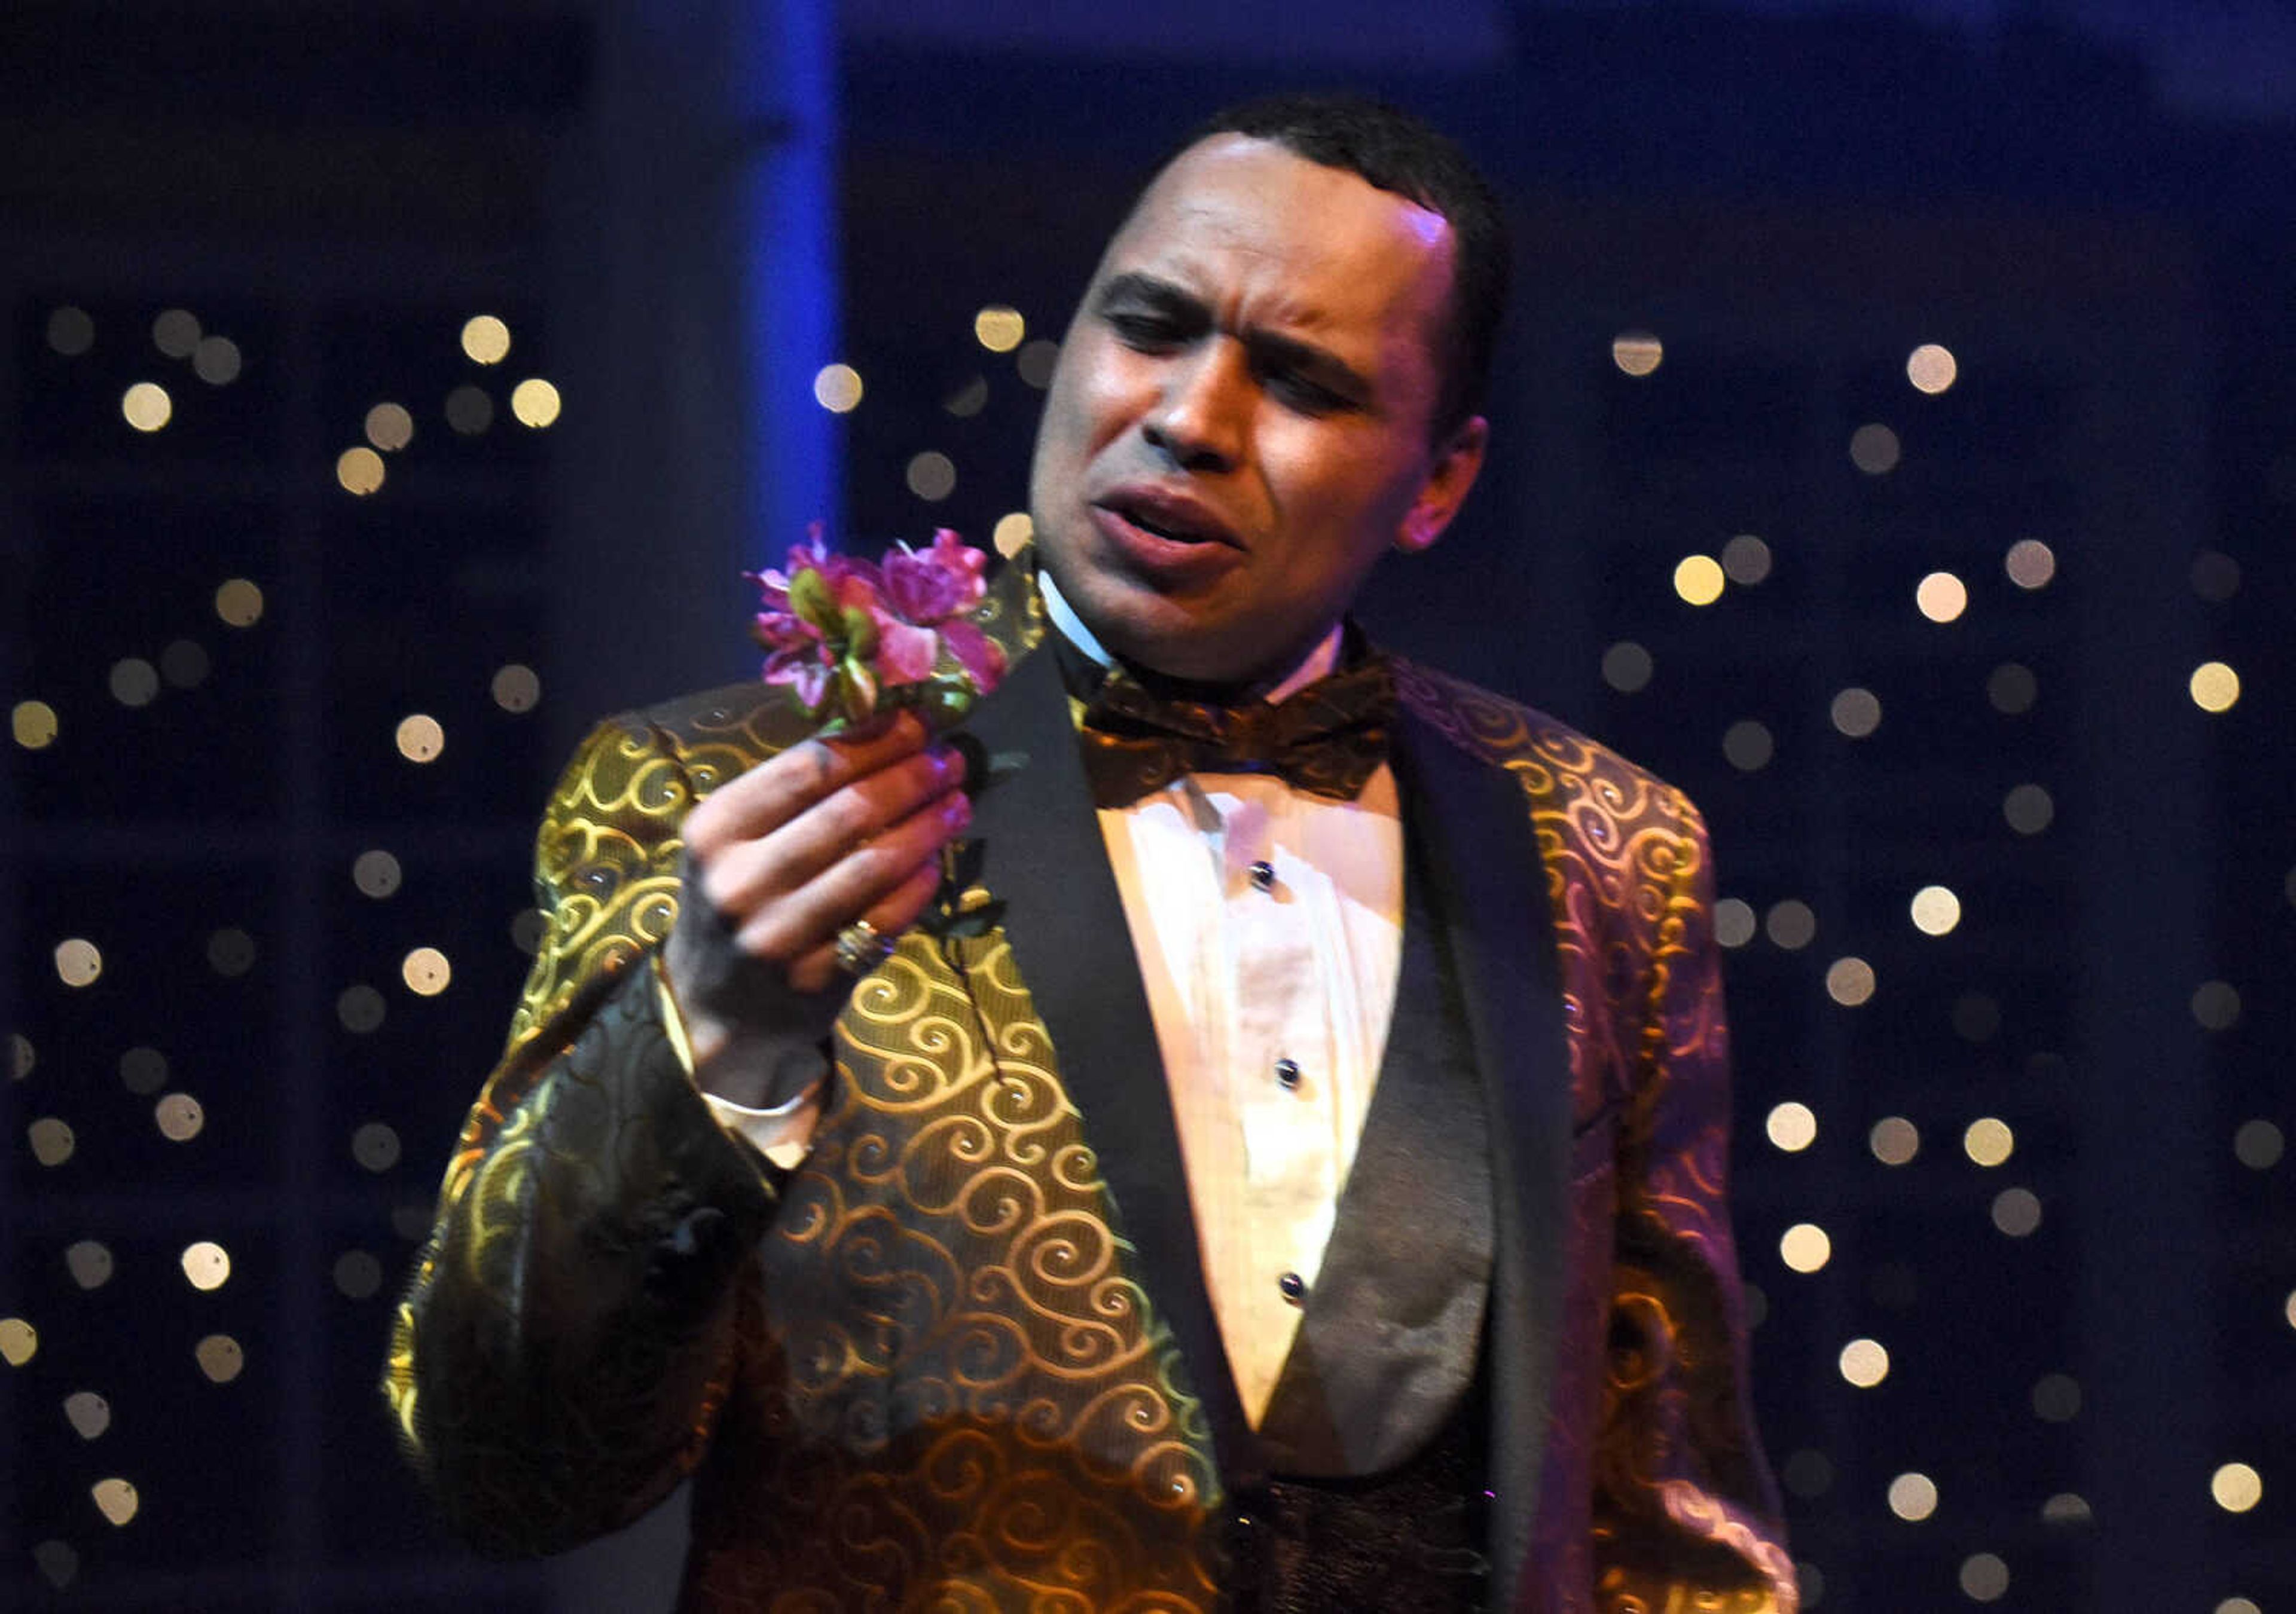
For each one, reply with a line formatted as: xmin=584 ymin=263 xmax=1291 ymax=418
xmin=684 ymin=576 xmax=1403 ymax=1426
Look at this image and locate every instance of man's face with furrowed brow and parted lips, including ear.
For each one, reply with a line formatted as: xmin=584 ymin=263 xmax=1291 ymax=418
xmin=1028 ymin=136 xmax=1483 ymax=682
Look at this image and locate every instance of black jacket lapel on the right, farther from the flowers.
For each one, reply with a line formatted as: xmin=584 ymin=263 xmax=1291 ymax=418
xmin=1396 ymin=707 xmax=1571 ymax=1607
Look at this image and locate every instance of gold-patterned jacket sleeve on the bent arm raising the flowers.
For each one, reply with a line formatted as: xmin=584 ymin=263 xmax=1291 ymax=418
xmin=383 ymin=721 xmax=774 ymax=1554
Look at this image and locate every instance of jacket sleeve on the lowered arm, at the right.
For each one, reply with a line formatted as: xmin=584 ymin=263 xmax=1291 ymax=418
xmin=1593 ymin=792 xmax=1800 ymax=1614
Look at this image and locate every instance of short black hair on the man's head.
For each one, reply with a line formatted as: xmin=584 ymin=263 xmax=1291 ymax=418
xmin=1173 ymin=92 xmax=1513 ymax=443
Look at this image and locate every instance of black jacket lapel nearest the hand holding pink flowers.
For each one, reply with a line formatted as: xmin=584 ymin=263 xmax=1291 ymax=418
xmin=967 ymin=645 xmax=1260 ymax=1485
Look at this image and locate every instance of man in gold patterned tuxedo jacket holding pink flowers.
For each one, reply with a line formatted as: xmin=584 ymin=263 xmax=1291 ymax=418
xmin=386 ymin=99 xmax=1796 ymax=1614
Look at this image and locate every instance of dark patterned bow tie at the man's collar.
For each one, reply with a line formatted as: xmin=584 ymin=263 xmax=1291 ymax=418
xmin=1082 ymin=655 xmax=1396 ymax=808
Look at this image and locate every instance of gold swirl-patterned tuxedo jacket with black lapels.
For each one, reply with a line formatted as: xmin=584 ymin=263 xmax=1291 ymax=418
xmin=383 ymin=590 xmax=1796 ymax=1614
